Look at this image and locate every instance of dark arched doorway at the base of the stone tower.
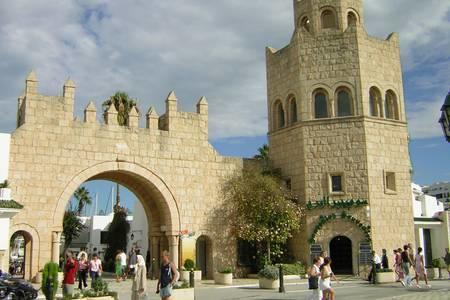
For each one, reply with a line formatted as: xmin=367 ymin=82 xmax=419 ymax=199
xmin=330 ymin=236 xmax=353 ymax=274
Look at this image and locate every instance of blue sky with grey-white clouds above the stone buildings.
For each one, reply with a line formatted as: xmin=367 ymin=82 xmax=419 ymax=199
xmin=0 ymin=0 xmax=450 ymax=211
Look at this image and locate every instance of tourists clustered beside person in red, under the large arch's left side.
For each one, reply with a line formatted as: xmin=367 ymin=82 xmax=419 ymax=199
xmin=63 ymin=251 xmax=103 ymax=295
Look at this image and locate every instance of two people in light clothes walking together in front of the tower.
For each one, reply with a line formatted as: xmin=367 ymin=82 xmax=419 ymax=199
xmin=308 ymin=251 xmax=339 ymax=300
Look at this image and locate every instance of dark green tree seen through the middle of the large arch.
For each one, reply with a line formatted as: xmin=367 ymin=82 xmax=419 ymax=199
xmin=105 ymin=206 xmax=130 ymax=262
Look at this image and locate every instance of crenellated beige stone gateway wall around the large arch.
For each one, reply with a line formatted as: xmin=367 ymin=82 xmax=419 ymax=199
xmin=5 ymin=72 xmax=242 ymax=279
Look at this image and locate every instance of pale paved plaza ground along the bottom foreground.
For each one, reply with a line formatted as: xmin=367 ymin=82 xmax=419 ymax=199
xmin=37 ymin=279 xmax=450 ymax=300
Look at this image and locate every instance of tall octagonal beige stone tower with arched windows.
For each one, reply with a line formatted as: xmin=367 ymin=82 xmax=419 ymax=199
xmin=266 ymin=0 xmax=414 ymax=273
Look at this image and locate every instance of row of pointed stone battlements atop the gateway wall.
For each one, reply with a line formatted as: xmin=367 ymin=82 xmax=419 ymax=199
xmin=17 ymin=71 xmax=208 ymax=139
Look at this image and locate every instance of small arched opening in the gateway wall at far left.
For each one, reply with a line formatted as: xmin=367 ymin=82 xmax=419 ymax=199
xmin=8 ymin=231 xmax=32 ymax=278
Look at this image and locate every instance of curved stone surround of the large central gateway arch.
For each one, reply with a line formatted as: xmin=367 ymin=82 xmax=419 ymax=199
xmin=52 ymin=161 xmax=180 ymax=265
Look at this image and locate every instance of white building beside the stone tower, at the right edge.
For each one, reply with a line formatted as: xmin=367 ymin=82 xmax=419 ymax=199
xmin=411 ymin=183 xmax=450 ymax=266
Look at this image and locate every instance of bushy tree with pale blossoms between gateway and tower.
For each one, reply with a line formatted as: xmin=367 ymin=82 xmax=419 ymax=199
xmin=222 ymin=170 xmax=303 ymax=263
